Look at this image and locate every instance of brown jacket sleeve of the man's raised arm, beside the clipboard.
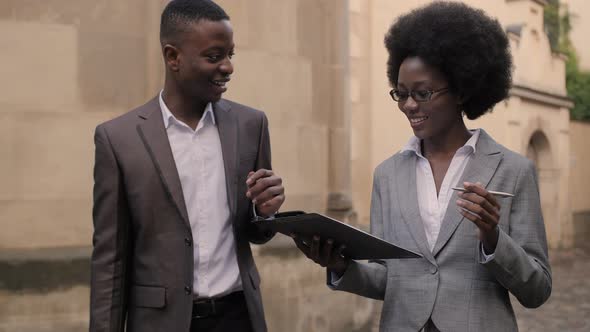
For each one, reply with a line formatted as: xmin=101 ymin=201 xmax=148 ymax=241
xmin=246 ymin=112 xmax=276 ymax=244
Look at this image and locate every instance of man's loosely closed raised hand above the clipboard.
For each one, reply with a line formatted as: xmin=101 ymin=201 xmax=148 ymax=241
xmin=246 ymin=169 xmax=285 ymax=217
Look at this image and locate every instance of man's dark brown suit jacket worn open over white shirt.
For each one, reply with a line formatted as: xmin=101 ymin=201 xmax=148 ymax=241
xmin=90 ymin=98 xmax=273 ymax=332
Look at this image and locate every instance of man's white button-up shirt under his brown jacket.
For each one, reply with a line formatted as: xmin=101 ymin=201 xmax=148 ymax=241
xmin=159 ymin=92 xmax=242 ymax=298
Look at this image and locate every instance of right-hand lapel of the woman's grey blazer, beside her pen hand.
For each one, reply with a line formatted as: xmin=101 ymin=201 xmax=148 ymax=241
xmin=432 ymin=129 xmax=502 ymax=256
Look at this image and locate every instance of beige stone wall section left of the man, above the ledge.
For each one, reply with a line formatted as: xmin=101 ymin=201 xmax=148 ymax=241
xmin=0 ymin=0 xmax=158 ymax=248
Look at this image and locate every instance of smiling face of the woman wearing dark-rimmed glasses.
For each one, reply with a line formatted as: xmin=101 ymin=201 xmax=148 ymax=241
xmin=394 ymin=57 xmax=463 ymax=140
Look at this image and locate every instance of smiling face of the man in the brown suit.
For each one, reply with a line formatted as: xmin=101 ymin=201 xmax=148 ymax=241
xmin=176 ymin=20 xmax=234 ymax=103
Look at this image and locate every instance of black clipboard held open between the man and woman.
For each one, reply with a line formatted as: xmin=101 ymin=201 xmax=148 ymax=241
xmin=255 ymin=211 xmax=422 ymax=260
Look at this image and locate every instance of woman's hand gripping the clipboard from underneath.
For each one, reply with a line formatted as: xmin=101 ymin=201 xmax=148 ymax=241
xmin=291 ymin=234 xmax=350 ymax=277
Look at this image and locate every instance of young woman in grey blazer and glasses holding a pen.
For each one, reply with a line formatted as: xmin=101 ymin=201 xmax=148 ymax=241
xmin=295 ymin=1 xmax=551 ymax=332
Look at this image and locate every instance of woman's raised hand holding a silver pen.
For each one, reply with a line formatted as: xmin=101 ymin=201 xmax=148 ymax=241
xmin=457 ymin=182 xmax=500 ymax=255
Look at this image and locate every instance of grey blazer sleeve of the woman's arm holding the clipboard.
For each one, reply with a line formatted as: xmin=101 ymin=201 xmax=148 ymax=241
xmin=326 ymin=171 xmax=387 ymax=300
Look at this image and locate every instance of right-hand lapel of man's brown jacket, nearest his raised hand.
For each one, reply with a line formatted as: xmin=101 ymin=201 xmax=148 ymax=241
xmin=213 ymin=99 xmax=238 ymax=219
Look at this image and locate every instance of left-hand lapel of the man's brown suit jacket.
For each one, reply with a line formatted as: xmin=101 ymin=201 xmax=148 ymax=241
xmin=137 ymin=97 xmax=190 ymax=228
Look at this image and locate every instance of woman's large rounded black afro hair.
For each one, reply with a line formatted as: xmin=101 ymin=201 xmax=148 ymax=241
xmin=385 ymin=1 xmax=512 ymax=120
